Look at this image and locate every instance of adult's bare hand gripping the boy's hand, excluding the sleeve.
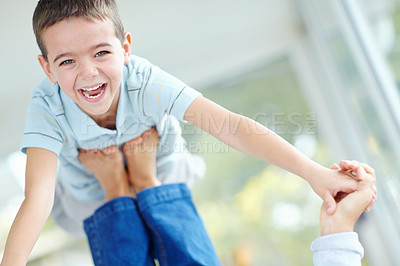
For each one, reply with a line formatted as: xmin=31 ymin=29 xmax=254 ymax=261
xmin=320 ymin=162 xmax=376 ymax=235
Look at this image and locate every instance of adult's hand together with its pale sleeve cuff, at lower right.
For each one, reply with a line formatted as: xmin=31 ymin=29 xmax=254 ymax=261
xmin=311 ymin=161 xmax=376 ymax=266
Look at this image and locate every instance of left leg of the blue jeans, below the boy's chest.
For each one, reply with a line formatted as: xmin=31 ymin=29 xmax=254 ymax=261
xmin=84 ymin=197 xmax=155 ymax=266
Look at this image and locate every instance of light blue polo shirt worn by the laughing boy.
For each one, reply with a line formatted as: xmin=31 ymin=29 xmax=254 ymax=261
xmin=21 ymin=56 xmax=201 ymax=201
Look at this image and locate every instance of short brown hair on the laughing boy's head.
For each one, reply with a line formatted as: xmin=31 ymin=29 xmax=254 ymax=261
xmin=32 ymin=0 xmax=124 ymax=60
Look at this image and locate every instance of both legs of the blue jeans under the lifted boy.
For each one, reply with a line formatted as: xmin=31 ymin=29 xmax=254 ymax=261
xmin=84 ymin=184 xmax=221 ymax=266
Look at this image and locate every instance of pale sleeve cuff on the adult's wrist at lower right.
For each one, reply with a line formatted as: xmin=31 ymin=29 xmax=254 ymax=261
xmin=311 ymin=232 xmax=364 ymax=266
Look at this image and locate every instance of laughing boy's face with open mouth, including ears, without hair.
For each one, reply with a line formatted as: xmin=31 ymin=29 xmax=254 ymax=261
xmin=39 ymin=18 xmax=131 ymax=119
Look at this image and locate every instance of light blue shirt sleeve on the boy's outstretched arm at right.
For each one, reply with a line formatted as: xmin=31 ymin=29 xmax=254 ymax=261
xmin=143 ymin=66 xmax=201 ymax=121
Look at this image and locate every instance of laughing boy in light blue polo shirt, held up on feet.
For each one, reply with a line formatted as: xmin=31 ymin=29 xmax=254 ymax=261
xmin=3 ymin=0 xmax=374 ymax=265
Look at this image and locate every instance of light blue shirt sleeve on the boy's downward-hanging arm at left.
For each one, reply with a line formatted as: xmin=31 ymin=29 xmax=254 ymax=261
xmin=21 ymin=96 xmax=64 ymax=155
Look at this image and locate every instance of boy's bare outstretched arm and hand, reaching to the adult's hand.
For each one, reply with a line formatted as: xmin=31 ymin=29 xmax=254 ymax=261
xmin=184 ymin=96 xmax=357 ymax=214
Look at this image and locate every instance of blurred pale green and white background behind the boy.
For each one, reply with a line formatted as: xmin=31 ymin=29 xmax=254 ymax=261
xmin=0 ymin=0 xmax=400 ymax=266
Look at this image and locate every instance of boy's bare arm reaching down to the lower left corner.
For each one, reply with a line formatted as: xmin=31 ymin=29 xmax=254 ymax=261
xmin=1 ymin=148 xmax=57 ymax=266
